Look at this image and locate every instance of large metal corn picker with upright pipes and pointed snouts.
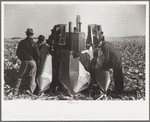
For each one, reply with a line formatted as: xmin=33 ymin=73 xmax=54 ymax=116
xmin=39 ymin=15 xmax=108 ymax=94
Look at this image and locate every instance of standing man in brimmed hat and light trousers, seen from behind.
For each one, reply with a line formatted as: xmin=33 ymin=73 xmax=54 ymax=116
xmin=13 ymin=28 xmax=40 ymax=96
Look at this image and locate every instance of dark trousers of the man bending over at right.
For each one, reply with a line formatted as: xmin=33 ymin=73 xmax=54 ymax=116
xmin=113 ymin=67 xmax=124 ymax=93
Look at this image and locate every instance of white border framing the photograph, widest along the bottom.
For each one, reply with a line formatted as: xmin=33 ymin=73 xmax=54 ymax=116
xmin=1 ymin=1 xmax=149 ymax=121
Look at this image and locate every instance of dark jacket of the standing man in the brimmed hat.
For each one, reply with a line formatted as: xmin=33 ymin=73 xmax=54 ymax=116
xmin=16 ymin=37 xmax=40 ymax=62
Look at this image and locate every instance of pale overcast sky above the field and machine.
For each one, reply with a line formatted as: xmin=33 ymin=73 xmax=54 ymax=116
xmin=4 ymin=2 xmax=146 ymax=38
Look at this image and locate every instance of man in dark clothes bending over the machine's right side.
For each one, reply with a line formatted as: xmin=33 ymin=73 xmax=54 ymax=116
xmin=100 ymin=41 xmax=124 ymax=93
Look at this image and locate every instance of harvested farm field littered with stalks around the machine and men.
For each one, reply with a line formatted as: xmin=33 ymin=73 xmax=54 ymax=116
xmin=4 ymin=36 xmax=146 ymax=100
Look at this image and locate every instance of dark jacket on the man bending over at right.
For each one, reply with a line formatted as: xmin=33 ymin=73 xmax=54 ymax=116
xmin=101 ymin=41 xmax=122 ymax=69
